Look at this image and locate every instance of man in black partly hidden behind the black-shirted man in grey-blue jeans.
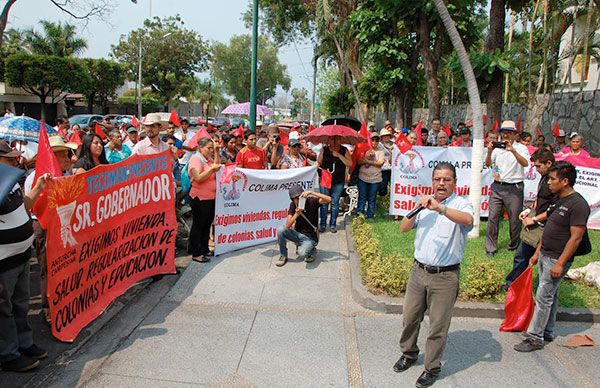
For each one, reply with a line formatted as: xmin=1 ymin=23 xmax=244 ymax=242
xmin=505 ymin=150 xmax=556 ymax=289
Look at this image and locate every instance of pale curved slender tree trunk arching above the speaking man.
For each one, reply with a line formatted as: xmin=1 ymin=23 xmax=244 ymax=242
xmin=434 ymin=0 xmax=482 ymax=237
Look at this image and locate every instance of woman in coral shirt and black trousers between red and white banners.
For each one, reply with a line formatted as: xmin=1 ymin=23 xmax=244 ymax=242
xmin=188 ymin=137 xmax=221 ymax=263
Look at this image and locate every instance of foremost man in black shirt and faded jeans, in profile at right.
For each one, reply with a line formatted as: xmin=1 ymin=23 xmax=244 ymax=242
xmin=514 ymin=161 xmax=590 ymax=352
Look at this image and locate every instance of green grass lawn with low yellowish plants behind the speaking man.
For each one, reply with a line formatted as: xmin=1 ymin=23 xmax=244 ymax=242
xmin=353 ymin=209 xmax=600 ymax=308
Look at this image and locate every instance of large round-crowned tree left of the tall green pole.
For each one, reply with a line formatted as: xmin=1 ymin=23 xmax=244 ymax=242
xmin=111 ymin=16 xmax=208 ymax=104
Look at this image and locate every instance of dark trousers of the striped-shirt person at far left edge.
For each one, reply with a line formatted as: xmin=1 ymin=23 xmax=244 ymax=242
xmin=0 ymin=260 xmax=33 ymax=362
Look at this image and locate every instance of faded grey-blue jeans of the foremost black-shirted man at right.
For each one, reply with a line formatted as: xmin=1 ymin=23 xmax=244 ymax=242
xmin=527 ymin=253 xmax=572 ymax=341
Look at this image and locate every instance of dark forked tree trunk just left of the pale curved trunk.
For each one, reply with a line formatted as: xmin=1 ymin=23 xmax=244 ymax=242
xmin=416 ymin=11 xmax=442 ymax=120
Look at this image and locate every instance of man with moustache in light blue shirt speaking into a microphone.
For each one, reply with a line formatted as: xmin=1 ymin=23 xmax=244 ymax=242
xmin=393 ymin=162 xmax=474 ymax=387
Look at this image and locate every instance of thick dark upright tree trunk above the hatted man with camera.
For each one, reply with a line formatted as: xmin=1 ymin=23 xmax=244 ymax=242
xmin=485 ymin=0 xmax=506 ymax=126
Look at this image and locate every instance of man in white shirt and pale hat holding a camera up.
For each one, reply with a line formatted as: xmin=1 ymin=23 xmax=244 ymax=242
xmin=485 ymin=120 xmax=530 ymax=257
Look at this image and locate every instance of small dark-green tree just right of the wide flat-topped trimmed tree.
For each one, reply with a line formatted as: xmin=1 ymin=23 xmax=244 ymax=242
xmin=81 ymin=58 xmax=125 ymax=113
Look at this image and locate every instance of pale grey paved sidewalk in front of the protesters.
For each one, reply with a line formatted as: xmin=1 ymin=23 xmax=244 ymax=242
xmin=43 ymin=227 xmax=600 ymax=388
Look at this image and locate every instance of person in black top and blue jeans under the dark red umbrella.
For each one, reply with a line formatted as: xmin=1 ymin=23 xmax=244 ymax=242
xmin=317 ymin=136 xmax=352 ymax=233
